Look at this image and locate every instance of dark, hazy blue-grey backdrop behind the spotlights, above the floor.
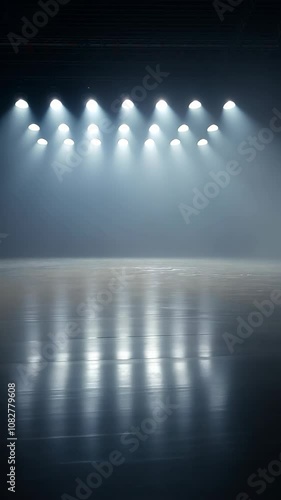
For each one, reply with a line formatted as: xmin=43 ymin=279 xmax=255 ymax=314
xmin=0 ymin=0 xmax=281 ymax=258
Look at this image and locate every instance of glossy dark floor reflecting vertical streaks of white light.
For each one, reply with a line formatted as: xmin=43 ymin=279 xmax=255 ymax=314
xmin=0 ymin=259 xmax=281 ymax=500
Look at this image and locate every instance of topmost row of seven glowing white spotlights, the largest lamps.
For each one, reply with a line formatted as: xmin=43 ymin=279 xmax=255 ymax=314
xmin=15 ymin=99 xmax=235 ymax=111
